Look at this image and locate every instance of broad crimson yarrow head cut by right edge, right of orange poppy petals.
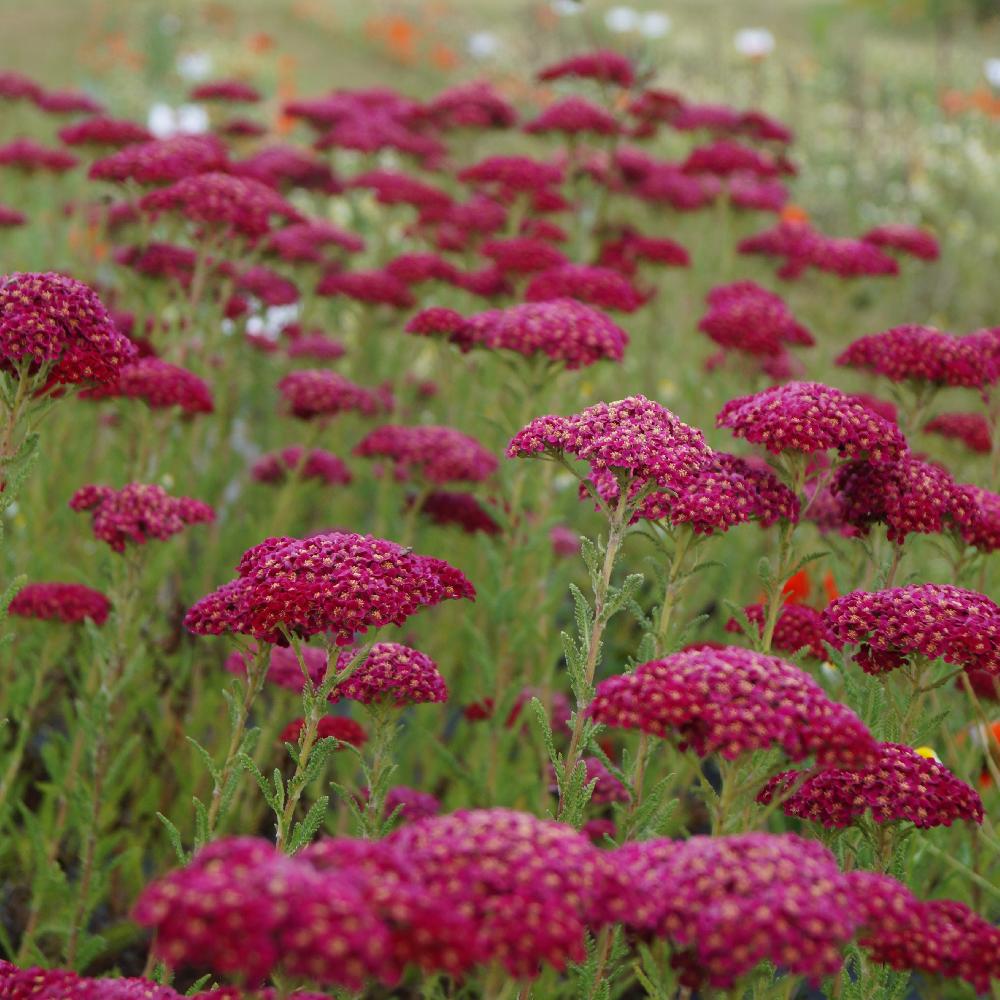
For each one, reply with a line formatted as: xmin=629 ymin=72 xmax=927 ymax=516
xmin=823 ymin=583 xmax=1000 ymax=674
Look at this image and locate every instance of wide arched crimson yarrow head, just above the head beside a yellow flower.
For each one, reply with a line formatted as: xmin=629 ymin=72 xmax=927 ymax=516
xmin=587 ymin=646 xmax=875 ymax=768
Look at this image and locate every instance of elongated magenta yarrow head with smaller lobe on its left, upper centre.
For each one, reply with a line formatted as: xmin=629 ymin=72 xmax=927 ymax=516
xmin=406 ymin=299 xmax=628 ymax=369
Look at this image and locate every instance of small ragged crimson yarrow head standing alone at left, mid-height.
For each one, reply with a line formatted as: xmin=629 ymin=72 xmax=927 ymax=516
xmin=69 ymin=483 xmax=215 ymax=552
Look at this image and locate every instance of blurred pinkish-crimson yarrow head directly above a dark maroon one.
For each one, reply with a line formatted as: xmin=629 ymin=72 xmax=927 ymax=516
xmin=354 ymin=424 xmax=499 ymax=485
